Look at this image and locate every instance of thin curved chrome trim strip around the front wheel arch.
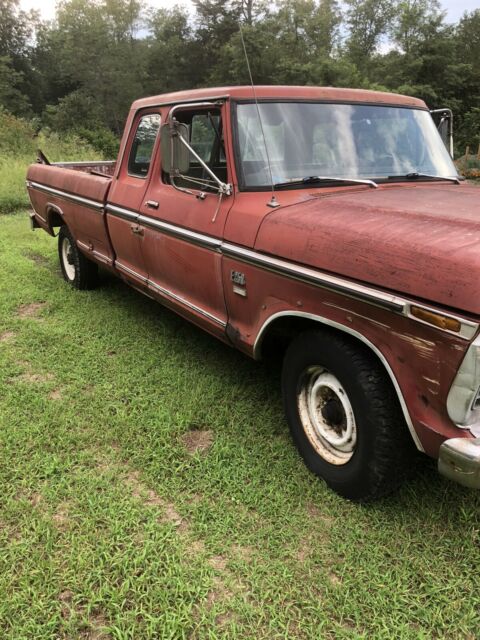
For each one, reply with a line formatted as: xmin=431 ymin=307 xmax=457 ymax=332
xmin=253 ymin=311 xmax=424 ymax=452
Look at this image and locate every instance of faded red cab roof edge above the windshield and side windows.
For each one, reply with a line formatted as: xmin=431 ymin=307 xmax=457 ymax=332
xmin=132 ymin=85 xmax=427 ymax=111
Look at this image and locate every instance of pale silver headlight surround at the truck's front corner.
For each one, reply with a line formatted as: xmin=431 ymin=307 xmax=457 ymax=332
xmin=447 ymin=337 xmax=480 ymax=428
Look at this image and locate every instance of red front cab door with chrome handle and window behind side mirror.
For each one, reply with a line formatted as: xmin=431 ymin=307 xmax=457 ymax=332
xmin=139 ymin=105 xmax=233 ymax=336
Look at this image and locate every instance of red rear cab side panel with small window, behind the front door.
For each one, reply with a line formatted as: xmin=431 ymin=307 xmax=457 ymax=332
xmin=106 ymin=111 xmax=160 ymax=286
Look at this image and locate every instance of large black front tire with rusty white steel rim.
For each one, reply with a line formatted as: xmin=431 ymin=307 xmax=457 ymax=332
xmin=282 ymin=330 xmax=415 ymax=502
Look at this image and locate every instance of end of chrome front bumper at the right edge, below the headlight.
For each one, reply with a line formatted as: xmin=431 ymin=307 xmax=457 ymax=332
xmin=438 ymin=438 xmax=480 ymax=489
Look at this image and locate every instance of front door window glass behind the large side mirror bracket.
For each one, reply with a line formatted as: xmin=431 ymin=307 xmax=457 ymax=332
xmin=164 ymin=109 xmax=227 ymax=191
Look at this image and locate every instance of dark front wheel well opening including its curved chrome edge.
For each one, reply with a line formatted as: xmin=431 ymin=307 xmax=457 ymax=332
xmin=254 ymin=312 xmax=423 ymax=451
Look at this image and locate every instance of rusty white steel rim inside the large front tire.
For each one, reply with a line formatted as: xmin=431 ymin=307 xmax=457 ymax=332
xmin=297 ymin=367 xmax=357 ymax=465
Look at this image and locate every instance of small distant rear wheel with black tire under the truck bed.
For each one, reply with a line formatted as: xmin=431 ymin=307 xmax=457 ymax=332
xmin=58 ymin=225 xmax=98 ymax=289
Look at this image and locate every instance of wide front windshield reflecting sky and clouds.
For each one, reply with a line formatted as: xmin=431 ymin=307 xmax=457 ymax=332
xmin=237 ymin=102 xmax=457 ymax=187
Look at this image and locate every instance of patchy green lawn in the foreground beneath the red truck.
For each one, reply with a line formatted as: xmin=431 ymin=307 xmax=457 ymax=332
xmin=0 ymin=213 xmax=480 ymax=640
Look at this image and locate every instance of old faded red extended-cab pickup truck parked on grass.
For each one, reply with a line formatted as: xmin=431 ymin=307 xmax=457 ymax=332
xmin=27 ymin=86 xmax=480 ymax=501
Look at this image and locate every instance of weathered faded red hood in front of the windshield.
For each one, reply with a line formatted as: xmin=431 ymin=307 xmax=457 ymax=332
xmin=255 ymin=183 xmax=480 ymax=316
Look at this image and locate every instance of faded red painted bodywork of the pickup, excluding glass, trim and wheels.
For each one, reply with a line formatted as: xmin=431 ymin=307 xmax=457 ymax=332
xmin=28 ymin=87 xmax=480 ymax=456
